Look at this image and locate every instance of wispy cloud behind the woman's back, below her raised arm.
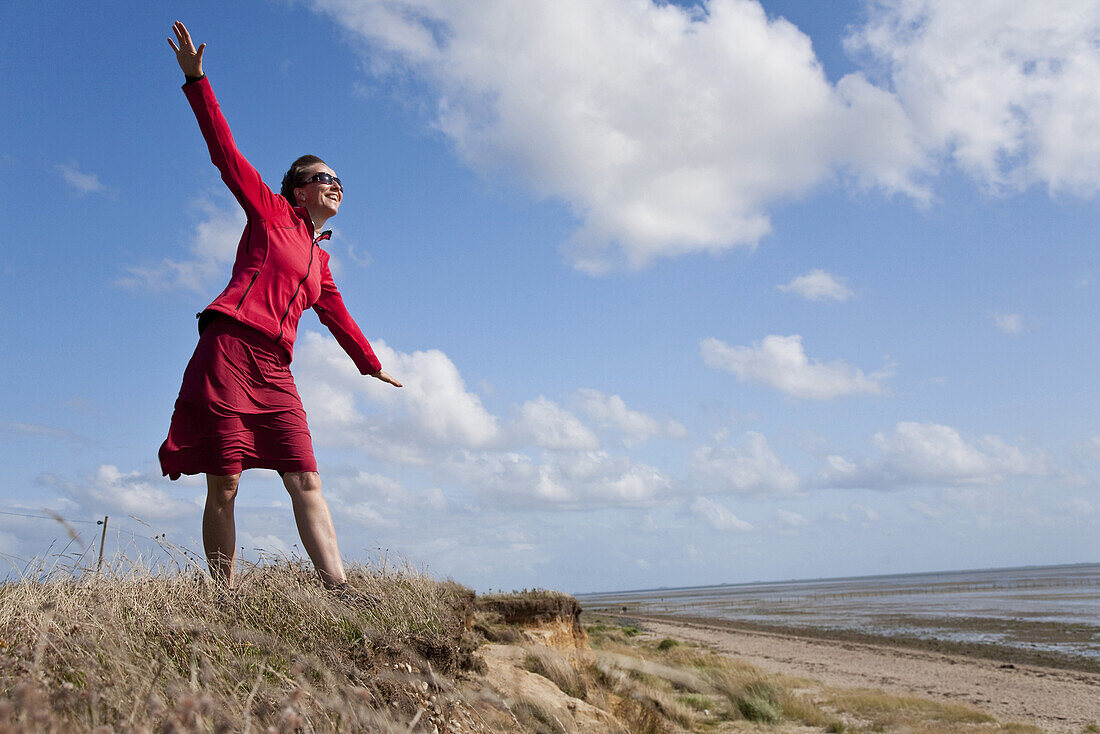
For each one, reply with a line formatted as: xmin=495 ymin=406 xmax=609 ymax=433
xmin=119 ymin=196 xmax=245 ymax=293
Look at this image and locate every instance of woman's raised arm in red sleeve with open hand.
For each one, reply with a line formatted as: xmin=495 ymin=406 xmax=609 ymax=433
xmin=168 ymin=21 xmax=290 ymax=219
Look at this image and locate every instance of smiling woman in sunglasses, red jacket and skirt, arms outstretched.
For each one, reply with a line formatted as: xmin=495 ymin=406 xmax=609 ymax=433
xmin=160 ymin=21 xmax=402 ymax=587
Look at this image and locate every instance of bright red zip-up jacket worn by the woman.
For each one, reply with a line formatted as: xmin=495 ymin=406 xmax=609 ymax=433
xmin=184 ymin=77 xmax=382 ymax=374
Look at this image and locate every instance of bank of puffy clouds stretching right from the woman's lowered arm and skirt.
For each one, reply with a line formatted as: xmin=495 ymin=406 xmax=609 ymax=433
xmin=296 ymin=331 xmax=672 ymax=508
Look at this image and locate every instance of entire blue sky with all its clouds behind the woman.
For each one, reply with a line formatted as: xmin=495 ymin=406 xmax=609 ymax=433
xmin=0 ymin=0 xmax=1100 ymax=591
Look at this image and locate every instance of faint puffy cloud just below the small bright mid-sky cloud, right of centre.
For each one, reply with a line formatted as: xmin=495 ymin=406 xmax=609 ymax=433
xmin=692 ymin=431 xmax=800 ymax=495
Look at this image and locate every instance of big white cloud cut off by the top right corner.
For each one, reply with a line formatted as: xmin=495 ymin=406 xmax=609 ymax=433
xmin=848 ymin=0 xmax=1100 ymax=195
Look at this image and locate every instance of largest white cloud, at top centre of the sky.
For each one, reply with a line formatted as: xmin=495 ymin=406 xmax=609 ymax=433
xmin=314 ymin=0 xmax=925 ymax=273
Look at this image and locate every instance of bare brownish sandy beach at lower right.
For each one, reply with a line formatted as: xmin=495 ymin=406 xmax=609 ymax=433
xmin=630 ymin=614 xmax=1100 ymax=734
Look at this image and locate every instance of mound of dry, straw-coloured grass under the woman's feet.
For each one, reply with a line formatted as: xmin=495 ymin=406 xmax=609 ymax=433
xmin=0 ymin=560 xmax=473 ymax=732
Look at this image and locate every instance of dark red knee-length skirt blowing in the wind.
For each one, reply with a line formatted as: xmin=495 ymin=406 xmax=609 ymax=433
xmin=160 ymin=316 xmax=317 ymax=479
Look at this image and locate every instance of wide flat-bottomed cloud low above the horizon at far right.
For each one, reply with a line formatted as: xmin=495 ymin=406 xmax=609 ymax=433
xmin=823 ymin=423 xmax=1054 ymax=490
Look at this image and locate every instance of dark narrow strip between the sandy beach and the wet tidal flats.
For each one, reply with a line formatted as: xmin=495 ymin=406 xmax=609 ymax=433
xmin=582 ymin=607 xmax=1100 ymax=673
